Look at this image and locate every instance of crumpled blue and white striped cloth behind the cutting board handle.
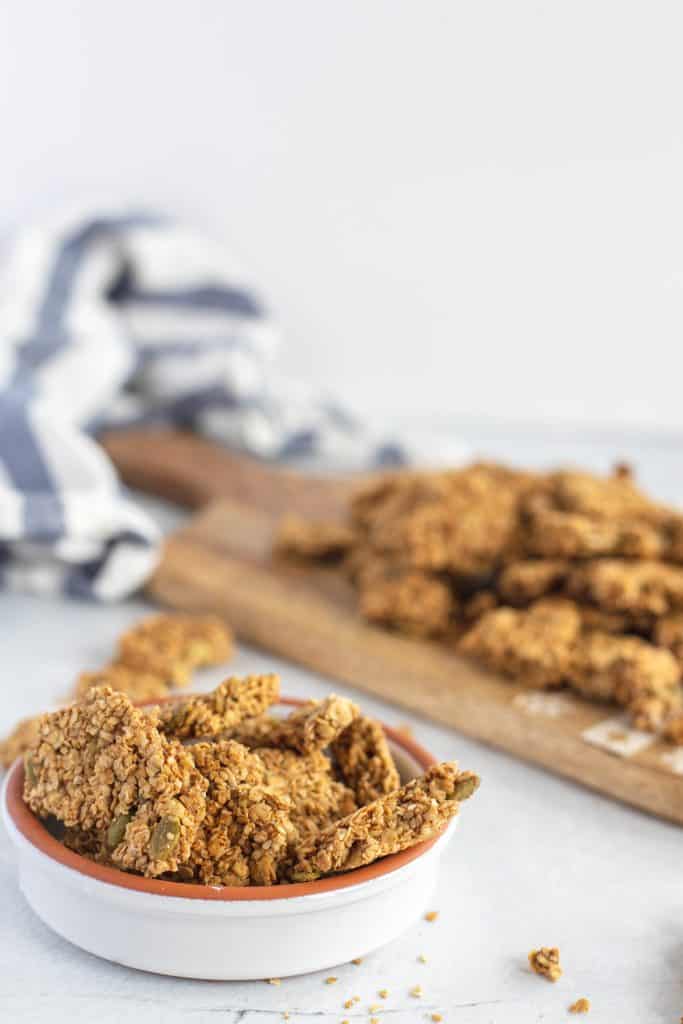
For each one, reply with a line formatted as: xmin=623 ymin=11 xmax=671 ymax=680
xmin=0 ymin=215 xmax=403 ymax=600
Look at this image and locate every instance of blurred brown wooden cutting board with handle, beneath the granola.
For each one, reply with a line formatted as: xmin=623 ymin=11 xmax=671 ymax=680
xmin=103 ymin=430 xmax=683 ymax=824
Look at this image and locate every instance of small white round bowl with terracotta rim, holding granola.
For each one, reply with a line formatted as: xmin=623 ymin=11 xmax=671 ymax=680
xmin=2 ymin=698 xmax=458 ymax=981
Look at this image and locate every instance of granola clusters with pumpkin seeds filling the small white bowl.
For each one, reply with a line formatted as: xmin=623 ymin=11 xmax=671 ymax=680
xmin=24 ymin=675 xmax=479 ymax=886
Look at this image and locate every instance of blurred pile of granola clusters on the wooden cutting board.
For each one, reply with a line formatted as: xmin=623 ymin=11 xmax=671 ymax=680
xmin=275 ymin=463 xmax=683 ymax=743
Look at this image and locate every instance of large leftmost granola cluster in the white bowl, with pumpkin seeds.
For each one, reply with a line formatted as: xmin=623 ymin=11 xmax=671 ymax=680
xmin=24 ymin=687 xmax=207 ymax=876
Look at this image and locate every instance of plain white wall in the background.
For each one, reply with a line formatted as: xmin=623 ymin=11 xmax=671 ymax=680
xmin=0 ymin=0 xmax=683 ymax=432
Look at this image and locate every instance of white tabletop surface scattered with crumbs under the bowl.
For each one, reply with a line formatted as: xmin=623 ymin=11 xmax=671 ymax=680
xmin=0 ymin=441 xmax=683 ymax=1024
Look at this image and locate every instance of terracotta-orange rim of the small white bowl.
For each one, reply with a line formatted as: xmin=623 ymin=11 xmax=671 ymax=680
xmin=5 ymin=693 xmax=447 ymax=902
